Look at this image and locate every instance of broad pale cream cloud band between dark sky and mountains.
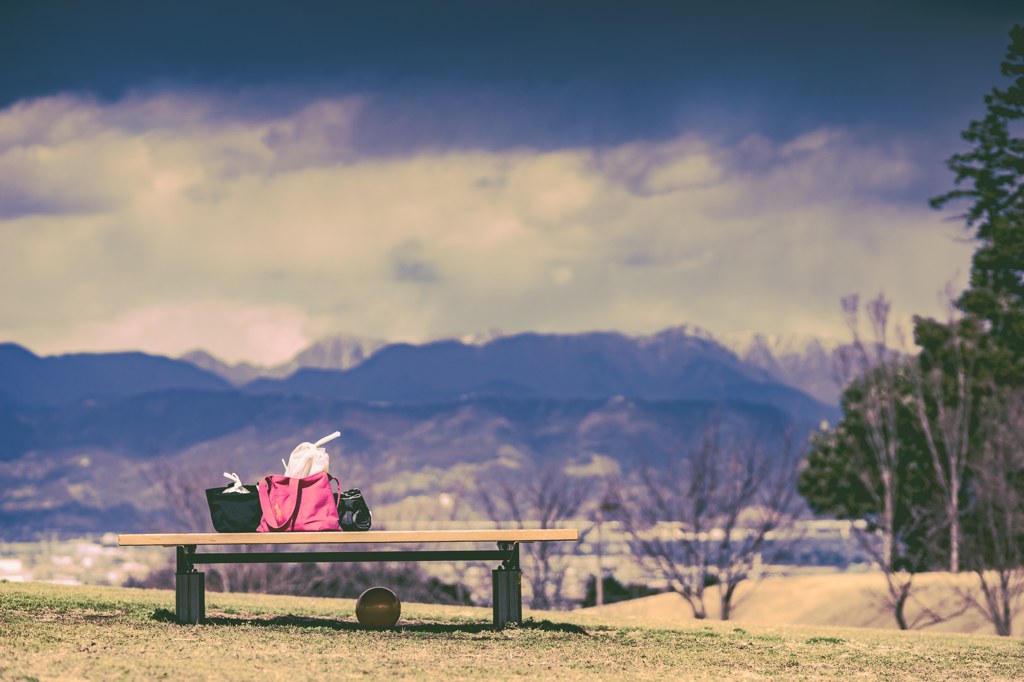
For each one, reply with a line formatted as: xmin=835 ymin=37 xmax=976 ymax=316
xmin=0 ymin=94 xmax=971 ymax=361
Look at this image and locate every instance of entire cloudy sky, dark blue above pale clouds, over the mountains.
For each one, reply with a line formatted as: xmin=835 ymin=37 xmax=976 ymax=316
xmin=0 ymin=0 xmax=1024 ymax=365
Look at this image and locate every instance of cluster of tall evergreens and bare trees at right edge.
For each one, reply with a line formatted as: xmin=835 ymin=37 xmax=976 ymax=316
xmin=799 ymin=27 xmax=1024 ymax=635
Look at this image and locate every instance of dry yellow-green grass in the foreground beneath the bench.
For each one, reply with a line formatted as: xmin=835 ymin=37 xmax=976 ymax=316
xmin=0 ymin=584 xmax=1024 ymax=682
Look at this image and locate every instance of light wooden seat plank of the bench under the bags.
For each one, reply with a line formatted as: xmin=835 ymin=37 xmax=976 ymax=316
xmin=118 ymin=528 xmax=580 ymax=547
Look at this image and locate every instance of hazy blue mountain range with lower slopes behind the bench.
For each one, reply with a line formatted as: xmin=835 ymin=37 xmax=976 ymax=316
xmin=0 ymin=328 xmax=838 ymax=540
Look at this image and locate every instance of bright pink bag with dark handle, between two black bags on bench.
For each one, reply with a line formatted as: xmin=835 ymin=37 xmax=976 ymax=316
xmin=256 ymin=471 xmax=341 ymax=532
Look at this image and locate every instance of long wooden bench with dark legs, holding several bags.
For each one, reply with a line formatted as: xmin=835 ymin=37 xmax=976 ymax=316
xmin=118 ymin=528 xmax=580 ymax=628
